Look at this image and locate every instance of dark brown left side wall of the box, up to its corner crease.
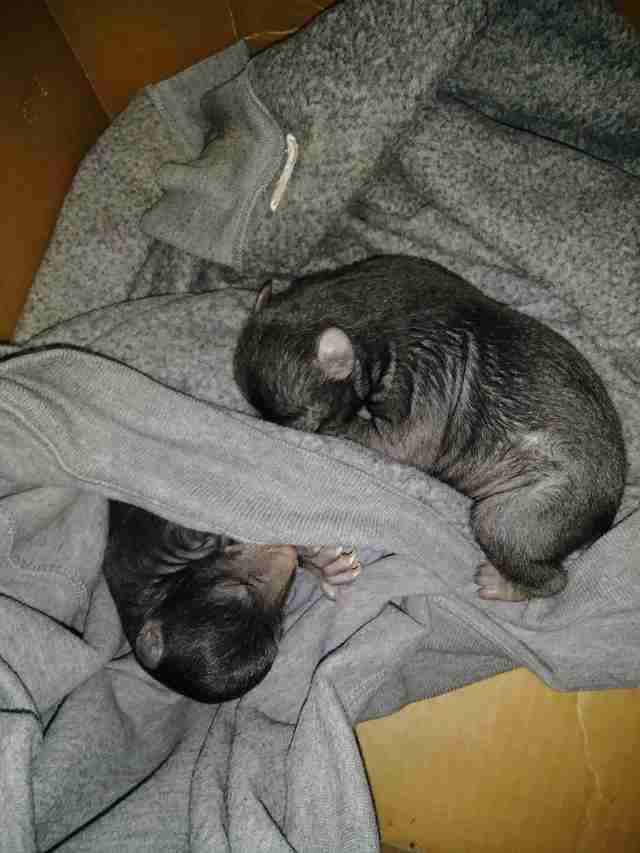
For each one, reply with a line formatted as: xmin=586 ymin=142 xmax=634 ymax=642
xmin=0 ymin=0 xmax=107 ymax=340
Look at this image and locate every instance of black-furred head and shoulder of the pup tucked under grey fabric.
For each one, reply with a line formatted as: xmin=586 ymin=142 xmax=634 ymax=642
xmin=103 ymin=501 xmax=288 ymax=702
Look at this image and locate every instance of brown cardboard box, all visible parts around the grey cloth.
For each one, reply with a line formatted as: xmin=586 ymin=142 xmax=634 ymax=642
xmin=0 ymin=0 xmax=640 ymax=853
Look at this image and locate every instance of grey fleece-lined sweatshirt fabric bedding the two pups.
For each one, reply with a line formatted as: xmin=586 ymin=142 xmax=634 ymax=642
xmin=0 ymin=0 xmax=640 ymax=853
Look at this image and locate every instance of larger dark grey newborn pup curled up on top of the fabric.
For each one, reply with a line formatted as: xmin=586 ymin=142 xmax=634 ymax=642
xmin=235 ymin=256 xmax=625 ymax=600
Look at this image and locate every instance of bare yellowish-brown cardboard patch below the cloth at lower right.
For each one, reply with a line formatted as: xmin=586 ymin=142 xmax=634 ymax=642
xmin=358 ymin=670 xmax=640 ymax=853
